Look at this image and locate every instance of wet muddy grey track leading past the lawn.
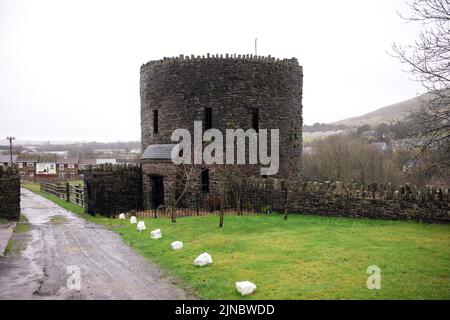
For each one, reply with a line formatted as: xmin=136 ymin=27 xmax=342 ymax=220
xmin=0 ymin=189 xmax=190 ymax=299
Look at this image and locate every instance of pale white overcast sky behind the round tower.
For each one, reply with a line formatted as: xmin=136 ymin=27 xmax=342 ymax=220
xmin=0 ymin=0 xmax=421 ymax=141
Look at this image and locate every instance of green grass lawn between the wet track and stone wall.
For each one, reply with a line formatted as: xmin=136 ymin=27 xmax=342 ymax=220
xmin=22 ymin=182 xmax=450 ymax=299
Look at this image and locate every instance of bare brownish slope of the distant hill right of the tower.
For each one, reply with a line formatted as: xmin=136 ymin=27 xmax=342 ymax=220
xmin=332 ymin=98 xmax=420 ymax=127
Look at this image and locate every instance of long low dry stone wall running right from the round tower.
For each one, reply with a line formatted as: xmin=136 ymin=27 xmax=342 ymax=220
xmin=243 ymin=179 xmax=450 ymax=223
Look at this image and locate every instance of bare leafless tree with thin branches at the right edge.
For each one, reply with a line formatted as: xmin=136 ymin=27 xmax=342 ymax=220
xmin=393 ymin=0 xmax=450 ymax=175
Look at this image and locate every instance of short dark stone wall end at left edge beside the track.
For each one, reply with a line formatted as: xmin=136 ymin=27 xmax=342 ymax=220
xmin=0 ymin=166 xmax=20 ymax=219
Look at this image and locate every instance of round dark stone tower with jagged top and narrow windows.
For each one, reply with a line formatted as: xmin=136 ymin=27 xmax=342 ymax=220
xmin=140 ymin=54 xmax=303 ymax=209
